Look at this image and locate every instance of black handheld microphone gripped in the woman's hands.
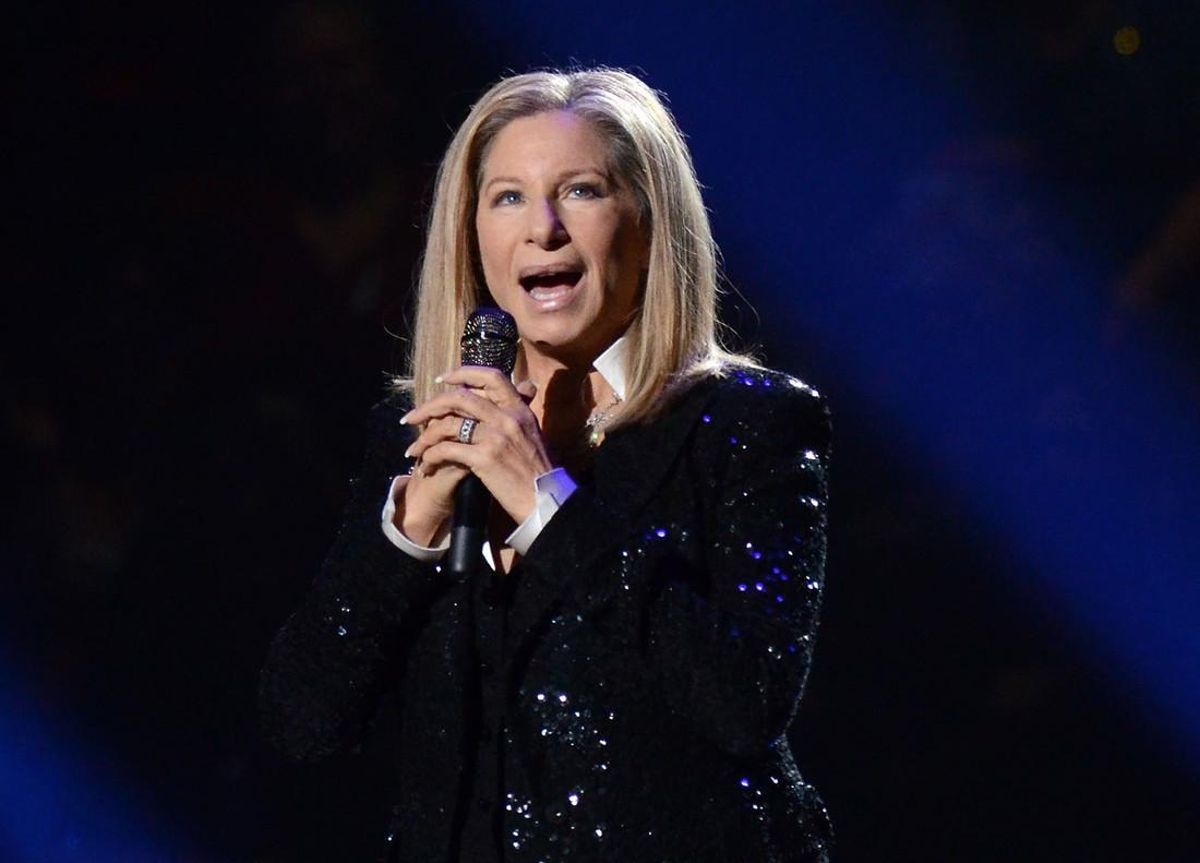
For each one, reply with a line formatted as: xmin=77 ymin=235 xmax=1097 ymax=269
xmin=449 ymin=307 xmax=517 ymax=576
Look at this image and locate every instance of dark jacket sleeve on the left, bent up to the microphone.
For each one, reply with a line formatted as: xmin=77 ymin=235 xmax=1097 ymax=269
xmin=259 ymin=398 xmax=443 ymax=760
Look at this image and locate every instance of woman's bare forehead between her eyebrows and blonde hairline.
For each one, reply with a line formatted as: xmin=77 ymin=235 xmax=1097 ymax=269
xmin=481 ymin=110 xmax=611 ymax=178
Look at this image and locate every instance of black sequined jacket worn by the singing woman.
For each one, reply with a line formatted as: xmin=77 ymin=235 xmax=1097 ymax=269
xmin=260 ymin=371 xmax=829 ymax=863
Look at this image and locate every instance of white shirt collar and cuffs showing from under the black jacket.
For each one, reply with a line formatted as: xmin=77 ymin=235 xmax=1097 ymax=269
xmin=382 ymin=336 xmax=629 ymax=569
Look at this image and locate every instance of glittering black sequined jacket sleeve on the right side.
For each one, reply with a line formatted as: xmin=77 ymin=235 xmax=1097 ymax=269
xmin=642 ymin=378 xmax=830 ymax=755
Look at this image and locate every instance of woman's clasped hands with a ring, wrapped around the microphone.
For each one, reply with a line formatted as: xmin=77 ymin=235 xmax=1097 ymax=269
xmin=401 ymin=366 xmax=553 ymax=543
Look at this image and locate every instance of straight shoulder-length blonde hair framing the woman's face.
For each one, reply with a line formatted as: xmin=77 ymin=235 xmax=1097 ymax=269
xmin=397 ymin=68 xmax=752 ymax=427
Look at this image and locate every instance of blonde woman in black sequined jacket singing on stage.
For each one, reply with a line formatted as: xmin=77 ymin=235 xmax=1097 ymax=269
xmin=262 ymin=70 xmax=829 ymax=863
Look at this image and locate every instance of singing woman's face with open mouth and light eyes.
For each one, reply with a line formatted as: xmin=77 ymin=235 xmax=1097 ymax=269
xmin=475 ymin=110 xmax=649 ymax=366
